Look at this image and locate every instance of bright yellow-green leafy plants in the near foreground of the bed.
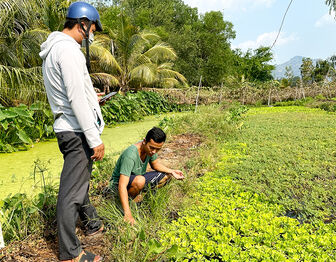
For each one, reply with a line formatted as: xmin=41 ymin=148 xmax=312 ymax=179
xmin=161 ymin=169 xmax=336 ymax=261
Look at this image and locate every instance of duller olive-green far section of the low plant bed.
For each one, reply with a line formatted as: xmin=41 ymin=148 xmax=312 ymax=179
xmin=223 ymin=107 xmax=336 ymax=221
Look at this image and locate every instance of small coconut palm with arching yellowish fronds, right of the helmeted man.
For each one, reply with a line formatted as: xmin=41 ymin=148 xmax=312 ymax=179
xmin=90 ymin=14 xmax=187 ymax=91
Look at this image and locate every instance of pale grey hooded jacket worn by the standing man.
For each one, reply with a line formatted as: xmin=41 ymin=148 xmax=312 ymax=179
xmin=40 ymin=32 xmax=105 ymax=148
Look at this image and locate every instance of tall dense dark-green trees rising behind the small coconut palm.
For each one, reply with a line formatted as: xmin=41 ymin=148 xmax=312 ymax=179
xmin=105 ymin=0 xmax=235 ymax=85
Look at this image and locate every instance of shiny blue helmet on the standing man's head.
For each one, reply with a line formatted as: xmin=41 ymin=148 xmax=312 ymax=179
xmin=66 ymin=2 xmax=103 ymax=31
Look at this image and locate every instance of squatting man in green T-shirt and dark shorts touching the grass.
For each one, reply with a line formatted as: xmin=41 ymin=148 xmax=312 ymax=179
xmin=109 ymin=127 xmax=184 ymax=225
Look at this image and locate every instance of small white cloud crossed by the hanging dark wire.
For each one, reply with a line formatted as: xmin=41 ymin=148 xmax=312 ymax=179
xmin=232 ymin=31 xmax=297 ymax=51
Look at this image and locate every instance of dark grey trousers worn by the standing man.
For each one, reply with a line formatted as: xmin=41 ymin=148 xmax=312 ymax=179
xmin=56 ymin=132 xmax=102 ymax=260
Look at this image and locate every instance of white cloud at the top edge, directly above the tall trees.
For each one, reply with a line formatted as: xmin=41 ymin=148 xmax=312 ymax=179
xmin=184 ymin=0 xmax=276 ymax=13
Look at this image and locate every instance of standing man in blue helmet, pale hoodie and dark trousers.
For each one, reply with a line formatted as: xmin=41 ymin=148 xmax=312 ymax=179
xmin=40 ymin=2 xmax=104 ymax=262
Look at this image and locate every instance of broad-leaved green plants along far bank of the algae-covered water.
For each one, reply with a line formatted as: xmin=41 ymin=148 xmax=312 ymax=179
xmin=0 ymin=91 xmax=188 ymax=152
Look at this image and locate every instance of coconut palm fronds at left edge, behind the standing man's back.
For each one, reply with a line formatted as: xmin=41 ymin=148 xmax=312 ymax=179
xmin=0 ymin=0 xmax=71 ymax=106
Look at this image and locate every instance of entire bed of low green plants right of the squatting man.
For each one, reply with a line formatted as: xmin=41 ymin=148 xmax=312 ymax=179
xmin=159 ymin=107 xmax=336 ymax=261
